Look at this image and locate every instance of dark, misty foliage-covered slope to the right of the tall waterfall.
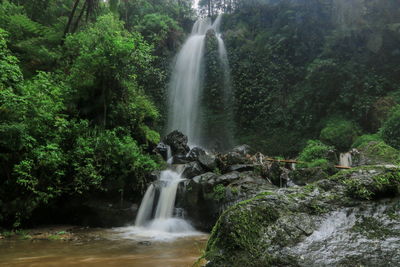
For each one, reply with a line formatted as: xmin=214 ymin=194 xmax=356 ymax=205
xmin=214 ymin=0 xmax=400 ymax=156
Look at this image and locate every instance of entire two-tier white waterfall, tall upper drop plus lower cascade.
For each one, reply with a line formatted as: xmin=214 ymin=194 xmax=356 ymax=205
xmin=135 ymin=15 xmax=231 ymax=238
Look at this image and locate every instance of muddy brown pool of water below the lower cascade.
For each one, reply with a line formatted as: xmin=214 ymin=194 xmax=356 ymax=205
xmin=0 ymin=227 xmax=208 ymax=267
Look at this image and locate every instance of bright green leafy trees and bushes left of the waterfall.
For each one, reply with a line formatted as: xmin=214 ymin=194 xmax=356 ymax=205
xmin=0 ymin=0 xmax=190 ymax=227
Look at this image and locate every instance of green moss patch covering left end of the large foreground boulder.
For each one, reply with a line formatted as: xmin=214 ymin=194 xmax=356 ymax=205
xmin=204 ymin=192 xmax=279 ymax=266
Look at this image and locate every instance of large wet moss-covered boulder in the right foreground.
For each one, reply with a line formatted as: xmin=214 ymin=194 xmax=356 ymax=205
xmin=204 ymin=166 xmax=400 ymax=266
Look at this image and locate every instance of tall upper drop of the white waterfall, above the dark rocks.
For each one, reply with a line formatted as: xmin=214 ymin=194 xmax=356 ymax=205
xmin=167 ymin=14 xmax=230 ymax=146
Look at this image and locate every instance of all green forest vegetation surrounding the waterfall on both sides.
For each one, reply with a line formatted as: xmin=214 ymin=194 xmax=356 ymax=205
xmin=0 ymin=0 xmax=400 ymax=230
